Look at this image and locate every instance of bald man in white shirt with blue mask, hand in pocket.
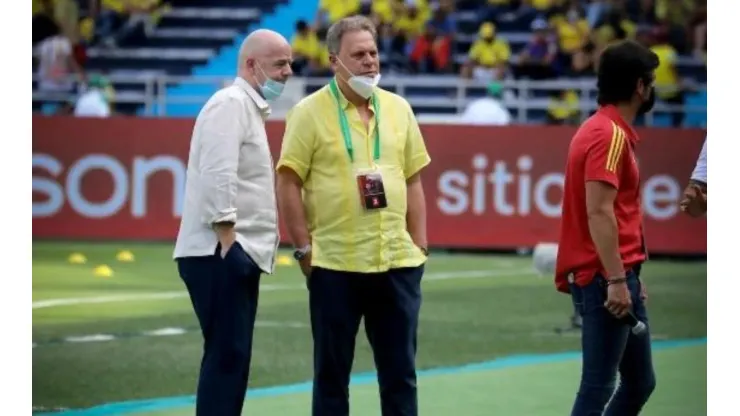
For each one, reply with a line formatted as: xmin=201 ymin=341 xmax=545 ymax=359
xmin=174 ymin=30 xmax=292 ymax=416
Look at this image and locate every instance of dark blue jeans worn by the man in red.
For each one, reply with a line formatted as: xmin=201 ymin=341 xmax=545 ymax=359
xmin=571 ymin=266 xmax=655 ymax=416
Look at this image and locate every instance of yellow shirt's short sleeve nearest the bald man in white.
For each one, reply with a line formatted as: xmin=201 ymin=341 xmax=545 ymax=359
xmin=276 ymin=104 xmax=316 ymax=182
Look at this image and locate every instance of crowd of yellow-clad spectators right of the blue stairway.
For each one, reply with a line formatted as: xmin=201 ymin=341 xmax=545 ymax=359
xmin=293 ymin=0 xmax=707 ymax=126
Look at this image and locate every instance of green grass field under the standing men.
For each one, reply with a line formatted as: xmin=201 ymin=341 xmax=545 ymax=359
xmin=33 ymin=242 xmax=707 ymax=416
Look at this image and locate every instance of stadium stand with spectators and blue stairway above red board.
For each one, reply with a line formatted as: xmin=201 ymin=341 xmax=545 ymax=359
xmin=33 ymin=0 xmax=706 ymax=126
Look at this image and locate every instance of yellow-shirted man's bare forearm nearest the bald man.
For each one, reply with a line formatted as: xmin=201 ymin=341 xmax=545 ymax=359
xmin=277 ymin=173 xmax=311 ymax=247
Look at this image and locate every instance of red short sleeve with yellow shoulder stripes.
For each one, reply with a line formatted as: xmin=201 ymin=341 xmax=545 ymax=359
xmin=586 ymin=123 xmax=627 ymax=189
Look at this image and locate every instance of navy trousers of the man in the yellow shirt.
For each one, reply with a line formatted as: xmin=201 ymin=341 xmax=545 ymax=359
xmin=308 ymin=265 xmax=424 ymax=416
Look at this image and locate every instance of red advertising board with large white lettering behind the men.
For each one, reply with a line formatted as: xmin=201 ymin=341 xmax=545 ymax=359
xmin=33 ymin=116 xmax=707 ymax=254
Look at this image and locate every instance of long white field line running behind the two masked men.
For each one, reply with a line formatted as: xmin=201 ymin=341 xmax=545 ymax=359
xmin=32 ymin=268 xmax=530 ymax=309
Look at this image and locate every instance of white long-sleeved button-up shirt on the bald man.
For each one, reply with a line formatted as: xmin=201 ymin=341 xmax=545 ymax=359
xmin=174 ymin=78 xmax=280 ymax=273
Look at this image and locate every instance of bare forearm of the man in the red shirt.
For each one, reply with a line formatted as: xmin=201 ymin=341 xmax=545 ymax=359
xmin=588 ymin=210 xmax=624 ymax=278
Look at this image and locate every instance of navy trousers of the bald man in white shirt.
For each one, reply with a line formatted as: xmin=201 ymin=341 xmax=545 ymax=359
xmin=177 ymin=243 xmax=262 ymax=416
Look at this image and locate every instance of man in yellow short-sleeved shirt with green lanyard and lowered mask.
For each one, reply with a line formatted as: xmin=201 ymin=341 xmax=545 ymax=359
xmin=277 ymin=16 xmax=430 ymax=416
